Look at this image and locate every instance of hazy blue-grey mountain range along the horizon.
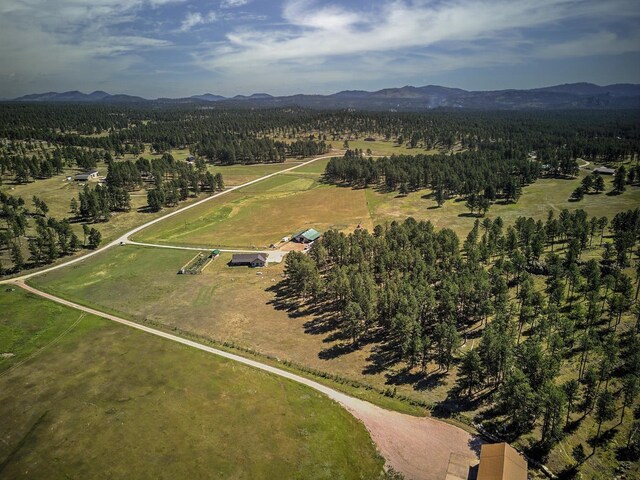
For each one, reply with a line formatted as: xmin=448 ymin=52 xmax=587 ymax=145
xmin=11 ymin=83 xmax=640 ymax=111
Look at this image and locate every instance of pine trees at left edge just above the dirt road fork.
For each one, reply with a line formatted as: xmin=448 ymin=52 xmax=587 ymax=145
xmin=0 ymin=192 xmax=102 ymax=275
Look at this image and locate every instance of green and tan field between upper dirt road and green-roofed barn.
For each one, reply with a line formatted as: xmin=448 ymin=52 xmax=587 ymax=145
xmin=134 ymin=171 xmax=372 ymax=248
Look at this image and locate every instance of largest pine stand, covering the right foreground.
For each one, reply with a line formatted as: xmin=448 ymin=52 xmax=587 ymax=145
xmin=285 ymin=209 xmax=640 ymax=458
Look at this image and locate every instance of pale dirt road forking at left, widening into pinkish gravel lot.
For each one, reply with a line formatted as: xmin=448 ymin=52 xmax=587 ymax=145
xmin=0 ymin=155 xmax=478 ymax=480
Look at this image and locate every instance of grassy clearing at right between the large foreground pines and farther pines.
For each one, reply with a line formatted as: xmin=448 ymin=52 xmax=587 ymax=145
xmin=366 ymin=170 xmax=640 ymax=239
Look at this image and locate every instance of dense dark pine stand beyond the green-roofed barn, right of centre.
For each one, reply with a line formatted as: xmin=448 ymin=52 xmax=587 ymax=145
xmin=325 ymin=150 xmax=541 ymax=212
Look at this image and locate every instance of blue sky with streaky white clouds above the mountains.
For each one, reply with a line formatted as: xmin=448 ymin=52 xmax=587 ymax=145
xmin=0 ymin=0 xmax=640 ymax=98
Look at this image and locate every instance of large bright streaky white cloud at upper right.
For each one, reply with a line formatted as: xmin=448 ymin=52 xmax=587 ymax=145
xmin=198 ymin=0 xmax=639 ymax=70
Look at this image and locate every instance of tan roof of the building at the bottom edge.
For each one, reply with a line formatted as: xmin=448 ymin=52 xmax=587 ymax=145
xmin=478 ymin=443 xmax=527 ymax=480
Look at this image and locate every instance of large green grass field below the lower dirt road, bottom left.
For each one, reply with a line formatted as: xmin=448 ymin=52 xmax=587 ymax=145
xmin=0 ymin=289 xmax=382 ymax=479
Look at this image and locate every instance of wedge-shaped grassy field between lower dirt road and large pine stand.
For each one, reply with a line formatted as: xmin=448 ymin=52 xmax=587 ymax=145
xmin=29 ymin=245 xmax=458 ymax=408
